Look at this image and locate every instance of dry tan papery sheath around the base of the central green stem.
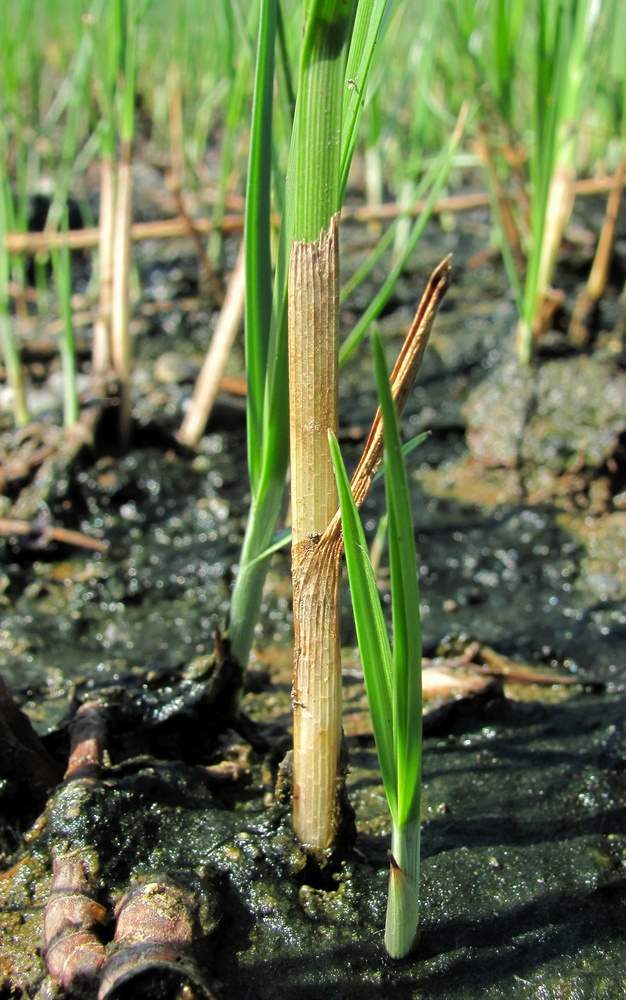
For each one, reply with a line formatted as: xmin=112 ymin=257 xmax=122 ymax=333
xmin=288 ymin=216 xmax=342 ymax=850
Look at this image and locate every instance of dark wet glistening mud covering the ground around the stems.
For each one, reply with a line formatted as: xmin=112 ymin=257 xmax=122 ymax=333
xmin=0 ymin=199 xmax=626 ymax=1000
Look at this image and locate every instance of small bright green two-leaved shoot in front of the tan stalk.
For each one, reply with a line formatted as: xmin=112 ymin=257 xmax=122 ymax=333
xmin=330 ymin=326 xmax=422 ymax=958
